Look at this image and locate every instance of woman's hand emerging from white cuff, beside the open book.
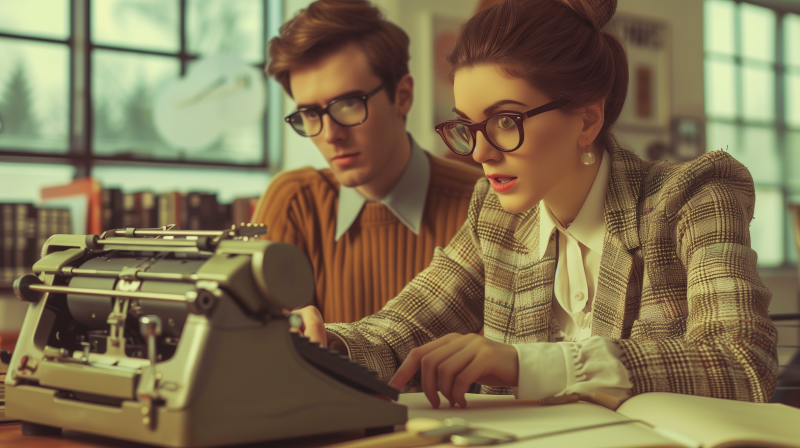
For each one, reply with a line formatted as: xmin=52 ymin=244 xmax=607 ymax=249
xmin=389 ymin=333 xmax=519 ymax=408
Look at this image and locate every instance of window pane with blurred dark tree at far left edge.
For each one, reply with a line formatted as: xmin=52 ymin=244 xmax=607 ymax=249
xmin=0 ymin=39 xmax=70 ymax=153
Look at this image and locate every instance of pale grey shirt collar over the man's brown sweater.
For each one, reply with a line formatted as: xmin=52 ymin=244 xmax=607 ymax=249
xmin=336 ymin=134 xmax=431 ymax=241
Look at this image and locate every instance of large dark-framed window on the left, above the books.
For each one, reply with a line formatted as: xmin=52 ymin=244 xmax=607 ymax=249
xmin=0 ymin=0 xmax=282 ymax=202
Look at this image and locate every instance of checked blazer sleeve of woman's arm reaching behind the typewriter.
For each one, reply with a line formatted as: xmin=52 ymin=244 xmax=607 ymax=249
xmin=325 ymin=178 xmax=487 ymax=378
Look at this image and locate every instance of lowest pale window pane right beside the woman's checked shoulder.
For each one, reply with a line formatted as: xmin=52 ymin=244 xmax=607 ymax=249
xmin=750 ymin=186 xmax=785 ymax=267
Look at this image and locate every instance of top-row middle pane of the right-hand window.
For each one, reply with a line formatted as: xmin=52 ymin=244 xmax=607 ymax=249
xmin=740 ymin=3 xmax=777 ymax=62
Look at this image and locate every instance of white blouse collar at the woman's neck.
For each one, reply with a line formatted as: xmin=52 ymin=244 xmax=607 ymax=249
xmin=539 ymin=151 xmax=611 ymax=258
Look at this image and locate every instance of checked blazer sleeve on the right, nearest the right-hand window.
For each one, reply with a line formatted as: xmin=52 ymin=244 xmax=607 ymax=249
xmin=619 ymin=151 xmax=777 ymax=402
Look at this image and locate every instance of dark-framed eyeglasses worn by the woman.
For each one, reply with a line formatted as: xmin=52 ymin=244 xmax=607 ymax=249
xmin=435 ymin=100 xmax=564 ymax=156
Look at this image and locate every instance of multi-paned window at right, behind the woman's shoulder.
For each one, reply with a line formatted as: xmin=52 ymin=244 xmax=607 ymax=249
xmin=703 ymin=0 xmax=800 ymax=267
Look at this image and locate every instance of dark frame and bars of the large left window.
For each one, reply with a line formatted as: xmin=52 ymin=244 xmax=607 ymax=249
xmin=0 ymin=0 xmax=284 ymax=178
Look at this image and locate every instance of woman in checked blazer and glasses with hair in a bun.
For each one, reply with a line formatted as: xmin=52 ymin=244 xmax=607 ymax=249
xmin=300 ymin=0 xmax=777 ymax=408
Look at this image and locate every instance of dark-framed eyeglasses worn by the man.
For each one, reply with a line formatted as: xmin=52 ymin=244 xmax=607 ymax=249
xmin=284 ymin=83 xmax=386 ymax=137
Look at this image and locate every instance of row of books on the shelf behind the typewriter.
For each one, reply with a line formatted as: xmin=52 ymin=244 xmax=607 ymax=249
xmin=0 ymin=178 xmax=257 ymax=288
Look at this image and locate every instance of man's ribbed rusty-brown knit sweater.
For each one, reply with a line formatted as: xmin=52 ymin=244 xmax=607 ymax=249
xmin=253 ymin=153 xmax=483 ymax=322
